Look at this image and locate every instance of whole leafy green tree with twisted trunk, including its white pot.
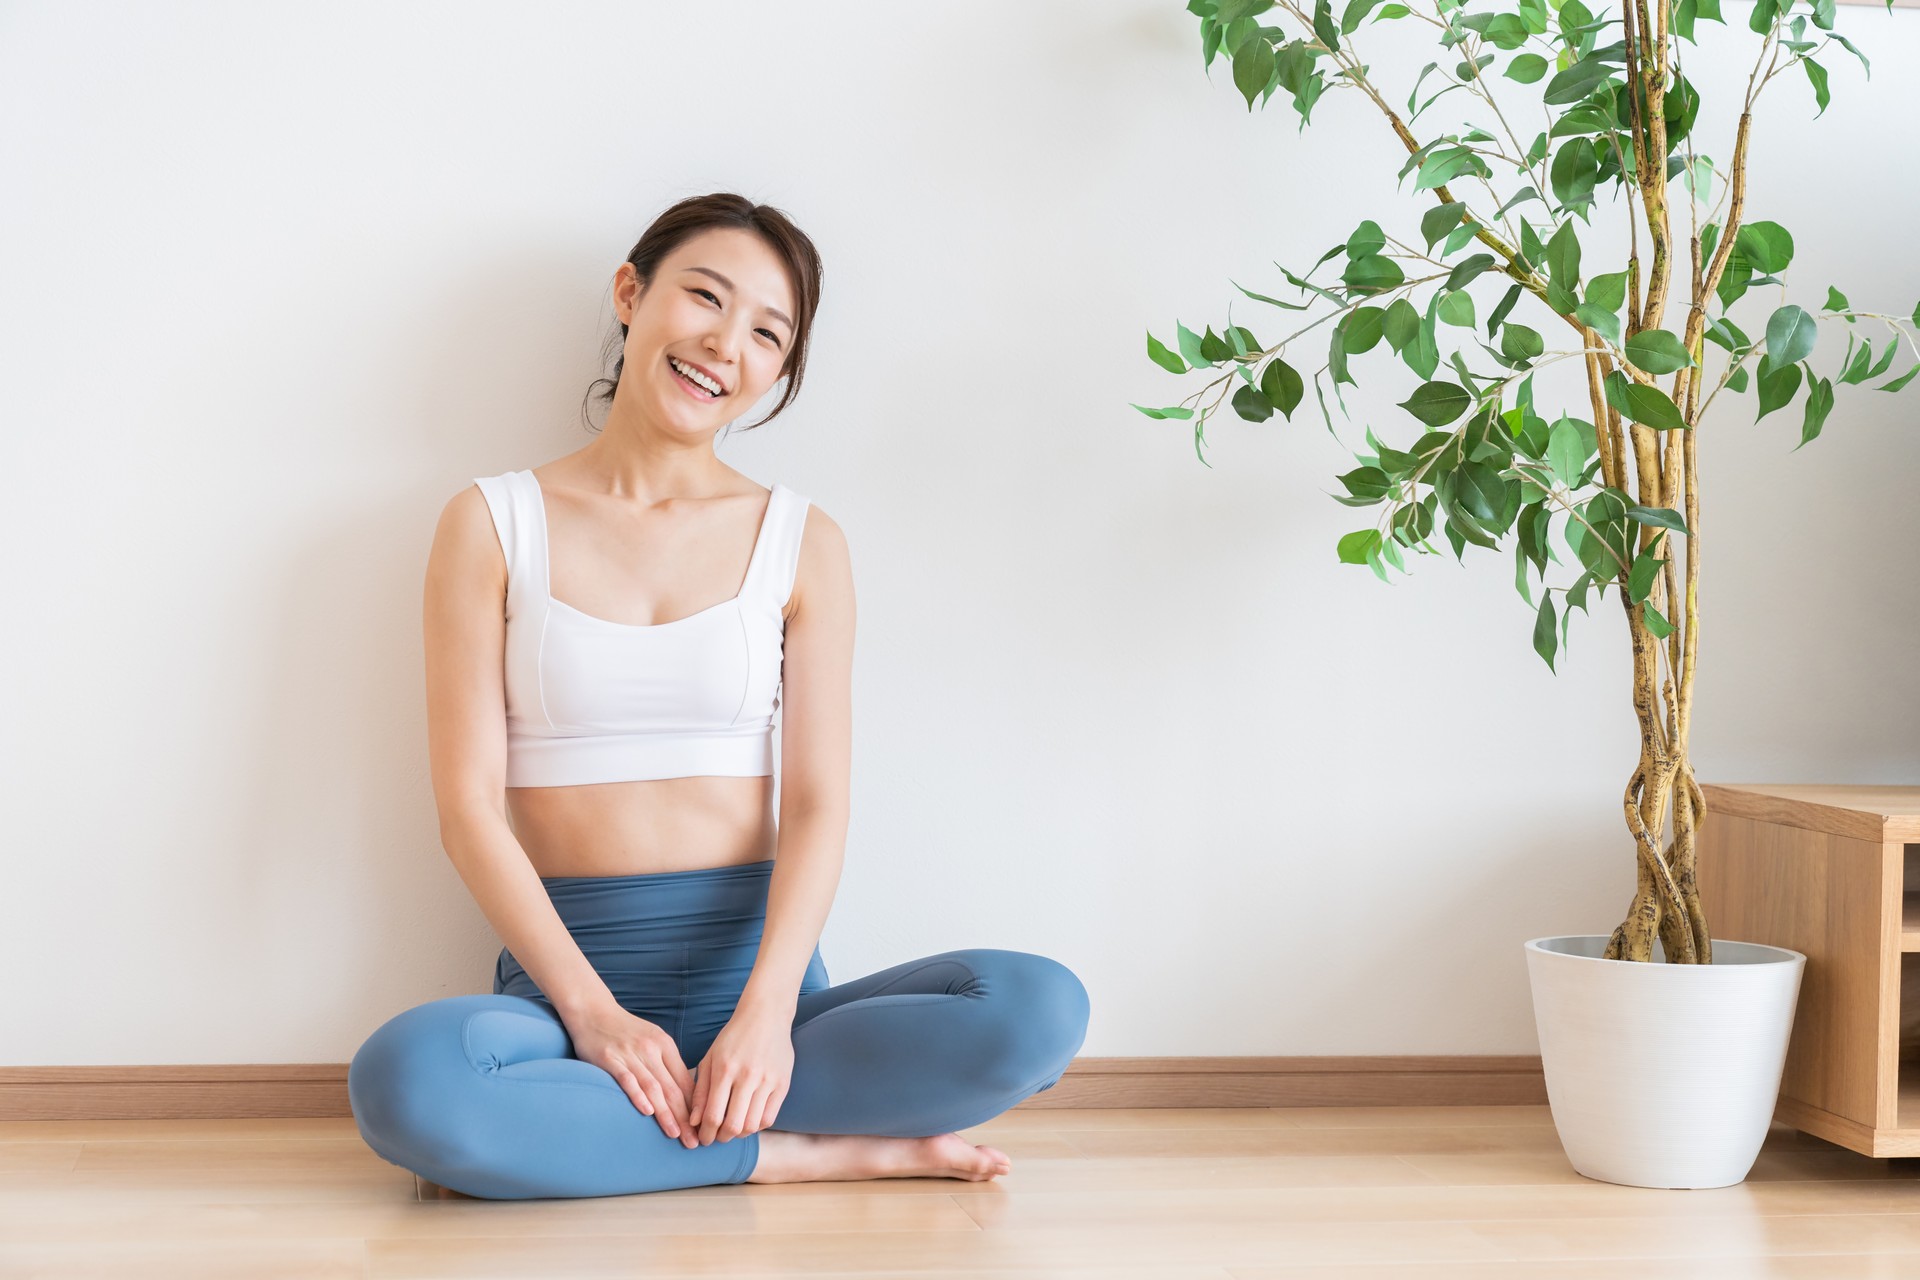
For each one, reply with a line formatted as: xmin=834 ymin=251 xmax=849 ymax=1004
xmin=1135 ymin=0 xmax=1920 ymax=1188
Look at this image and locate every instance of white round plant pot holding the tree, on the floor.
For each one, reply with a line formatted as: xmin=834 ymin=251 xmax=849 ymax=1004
xmin=1526 ymin=935 xmax=1807 ymax=1188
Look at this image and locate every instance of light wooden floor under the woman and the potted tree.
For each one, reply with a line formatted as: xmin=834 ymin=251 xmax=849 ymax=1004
xmin=0 ymin=1107 xmax=1920 ymax=1280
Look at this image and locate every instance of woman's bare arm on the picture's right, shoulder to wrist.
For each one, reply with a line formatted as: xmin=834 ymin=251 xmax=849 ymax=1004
xmin=737 ymin=507 xmax=854 ymax=1021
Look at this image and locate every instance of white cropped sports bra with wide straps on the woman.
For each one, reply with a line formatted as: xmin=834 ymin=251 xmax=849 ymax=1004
xmin=474 ymin=470 xmax=808 ymax=787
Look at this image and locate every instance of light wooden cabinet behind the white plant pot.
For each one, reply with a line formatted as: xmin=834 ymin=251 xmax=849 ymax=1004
xmin=1699 ymin=783 xmax=1920 ymax=1155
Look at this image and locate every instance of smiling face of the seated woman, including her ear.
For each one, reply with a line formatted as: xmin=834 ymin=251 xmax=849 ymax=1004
xmin=614 ymin=226 xmax=797 ymax=430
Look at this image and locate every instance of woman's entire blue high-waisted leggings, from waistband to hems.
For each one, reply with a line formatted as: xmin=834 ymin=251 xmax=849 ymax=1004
xmin=348 ymin=860 xmax=1089 ymax=1199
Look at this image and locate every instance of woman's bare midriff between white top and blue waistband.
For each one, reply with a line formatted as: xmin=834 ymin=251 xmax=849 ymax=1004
xmin=507 ymin=775 xmax=778 ymax=877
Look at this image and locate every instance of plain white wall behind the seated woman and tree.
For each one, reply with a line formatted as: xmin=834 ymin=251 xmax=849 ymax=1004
xmin=11 ymin=0 xmax=1920 ymax=1065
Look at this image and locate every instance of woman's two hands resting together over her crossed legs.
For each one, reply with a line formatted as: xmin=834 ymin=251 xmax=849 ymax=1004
xmin=566 ymin=1004 xmax=793 ymax=1150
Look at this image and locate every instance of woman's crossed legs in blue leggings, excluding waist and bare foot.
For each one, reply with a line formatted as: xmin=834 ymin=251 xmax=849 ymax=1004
xmin=348 ymin=948 xmax=1089 ymax=1199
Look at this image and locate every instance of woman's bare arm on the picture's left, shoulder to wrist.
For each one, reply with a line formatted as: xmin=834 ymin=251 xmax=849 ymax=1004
xmin=424 ymin=486 xmax=616 ymax=1019
